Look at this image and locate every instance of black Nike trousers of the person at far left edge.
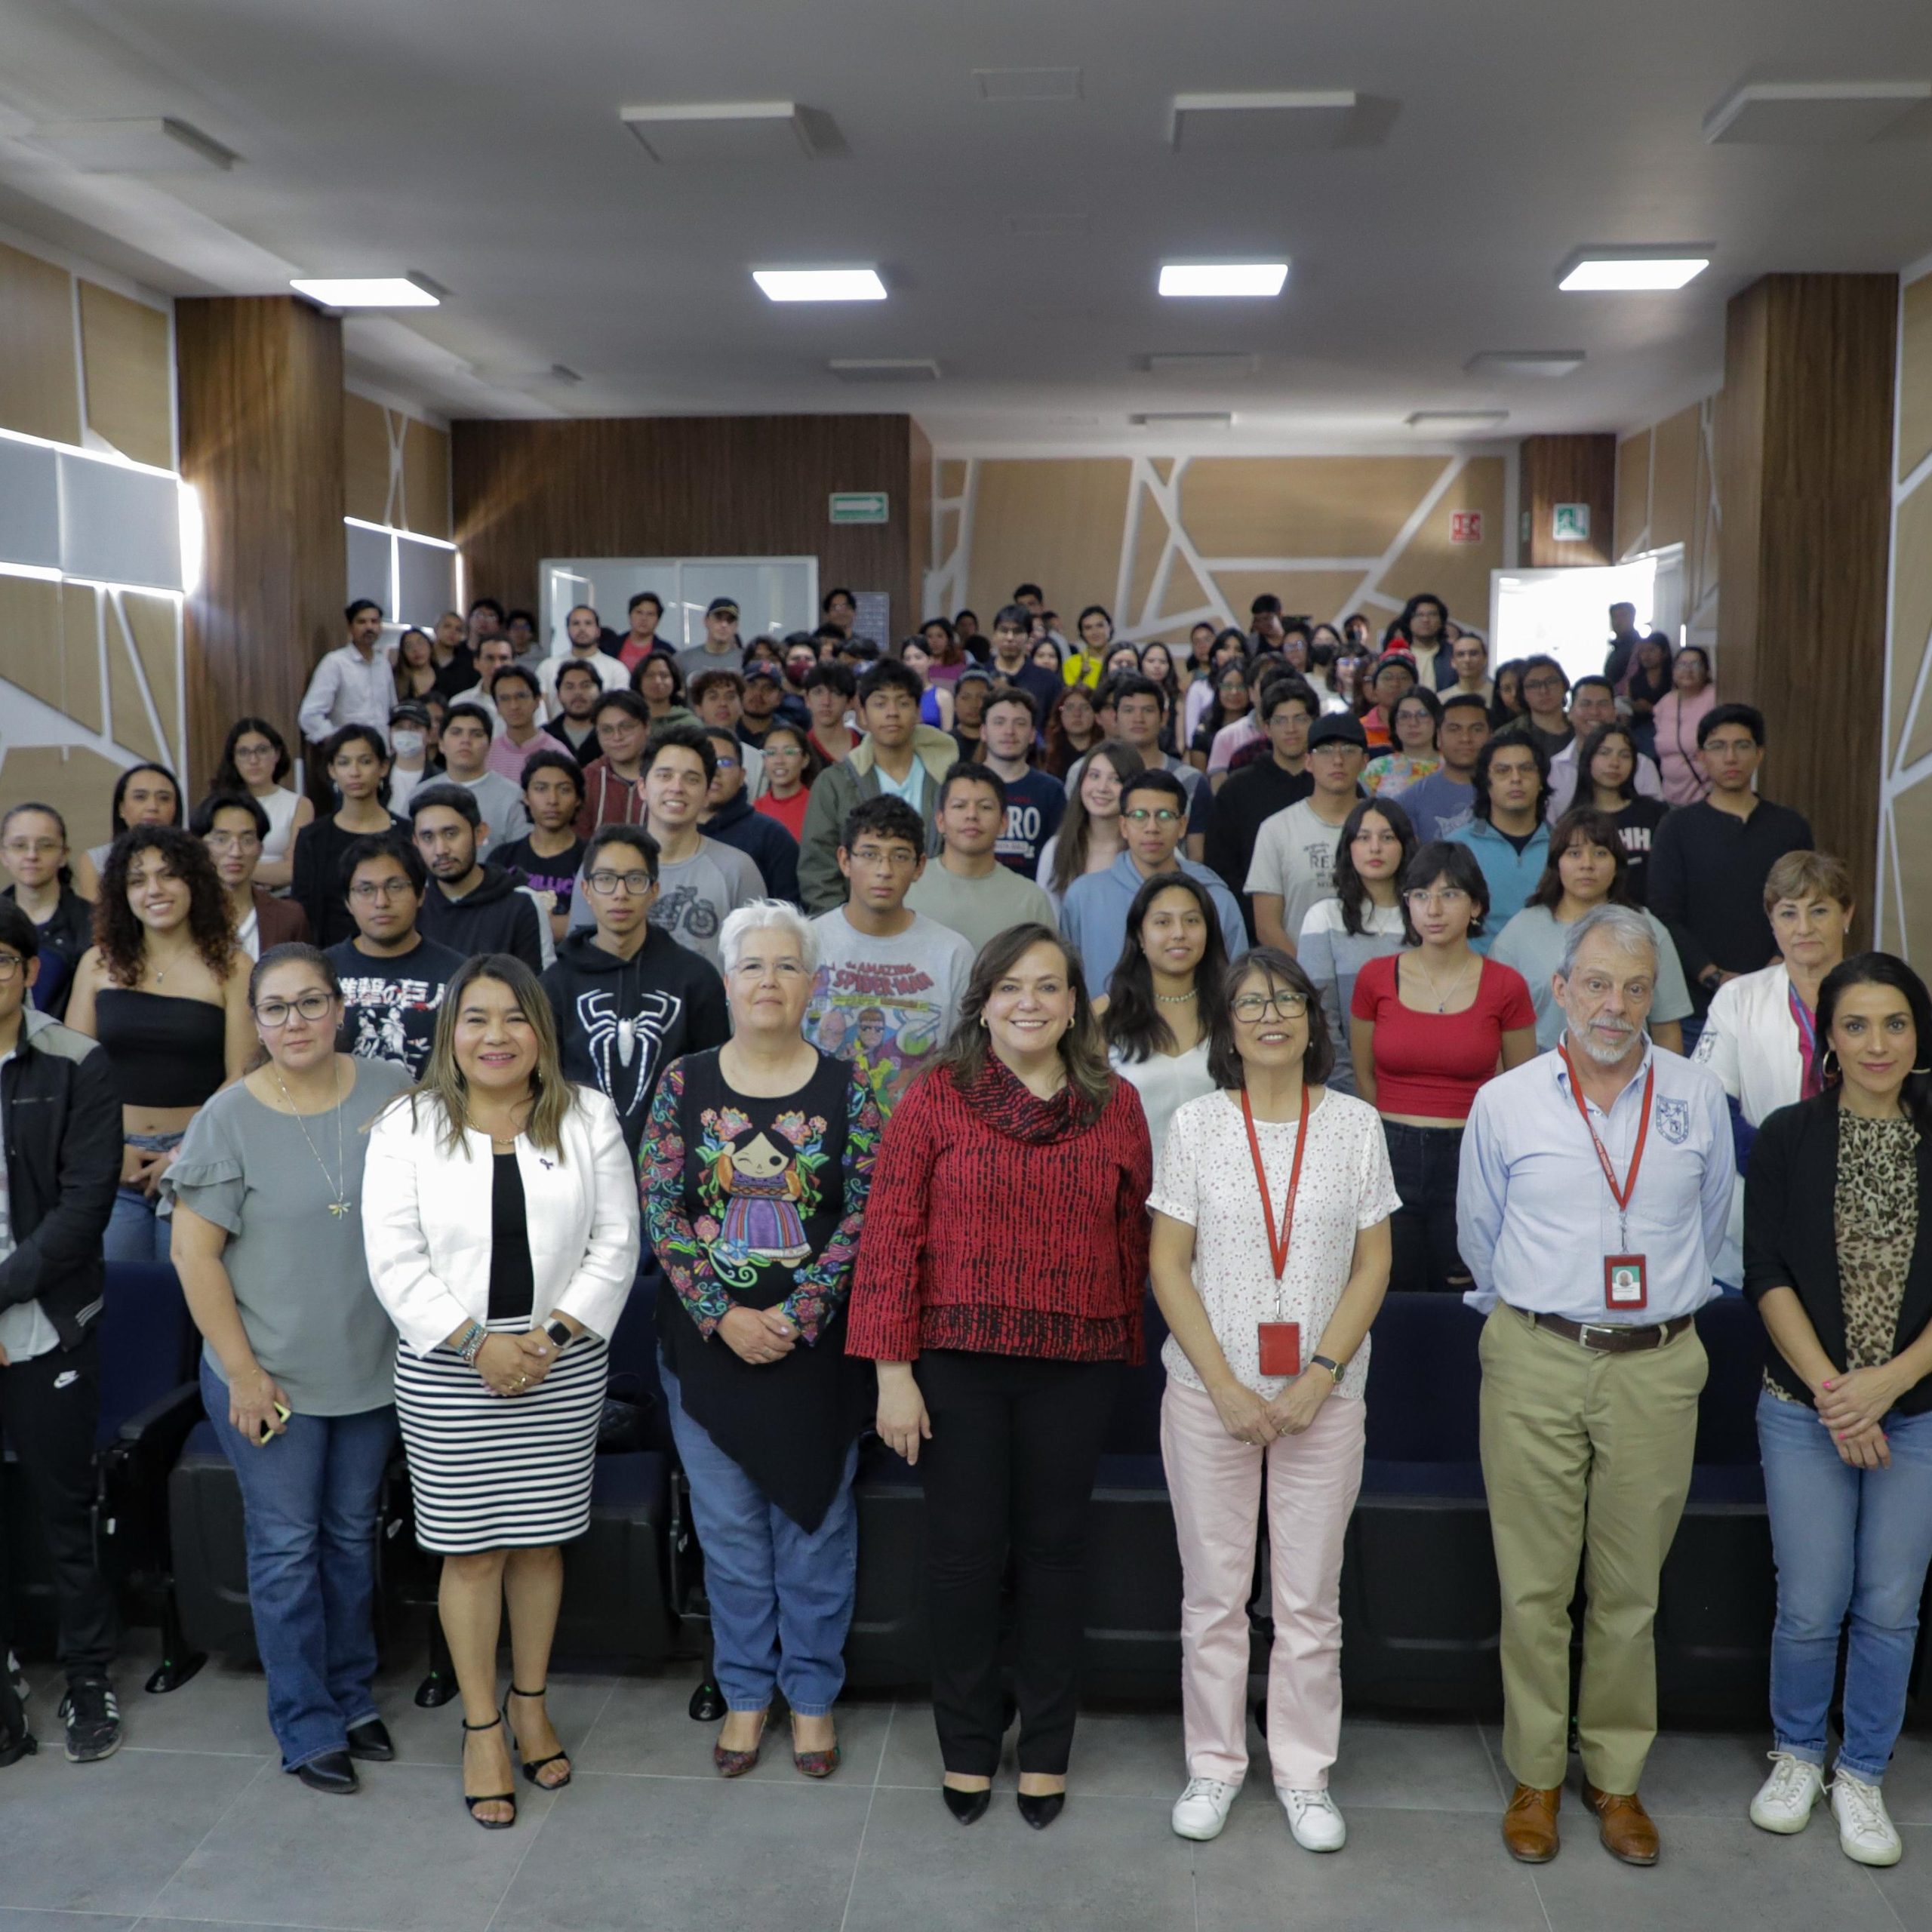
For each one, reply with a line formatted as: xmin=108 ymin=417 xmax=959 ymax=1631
xmin=0 ymin=1333 xmax=118 ymax=1683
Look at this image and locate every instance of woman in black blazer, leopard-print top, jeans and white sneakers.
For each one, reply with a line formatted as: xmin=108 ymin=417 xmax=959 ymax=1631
xmin=1745 ymin=952 xmax=1932 ymax=1866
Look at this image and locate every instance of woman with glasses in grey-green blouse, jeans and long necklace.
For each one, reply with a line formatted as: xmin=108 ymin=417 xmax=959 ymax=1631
xmin=166 ymin=945 xmax=410 ymax=1795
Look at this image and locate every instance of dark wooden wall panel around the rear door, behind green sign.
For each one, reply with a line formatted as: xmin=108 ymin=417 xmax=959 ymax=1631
xmin=450 ymin=415 xmax=924 ymax=628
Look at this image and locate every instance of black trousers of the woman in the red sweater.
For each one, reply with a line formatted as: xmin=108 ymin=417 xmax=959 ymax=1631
xmin=915 ymin=1349 xmax=1121 ymax=1777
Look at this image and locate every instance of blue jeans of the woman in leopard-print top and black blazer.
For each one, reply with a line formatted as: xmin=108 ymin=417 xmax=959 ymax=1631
xmin=1758 ymin=1393 xmax=1932 ymax=1783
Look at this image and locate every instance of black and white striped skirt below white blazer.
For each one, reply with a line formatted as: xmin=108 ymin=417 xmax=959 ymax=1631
xmin=396 ymin=1321 xmax=611 ymax=1555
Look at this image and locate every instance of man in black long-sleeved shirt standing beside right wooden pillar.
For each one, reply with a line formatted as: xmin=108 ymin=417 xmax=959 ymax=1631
xmin=1648 ymin=705 xmax=1812 ymax=1018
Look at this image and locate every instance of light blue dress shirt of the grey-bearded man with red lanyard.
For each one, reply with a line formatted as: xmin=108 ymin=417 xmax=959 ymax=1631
xmin=1457 ymin=1049 xmax=1737 ymax=1327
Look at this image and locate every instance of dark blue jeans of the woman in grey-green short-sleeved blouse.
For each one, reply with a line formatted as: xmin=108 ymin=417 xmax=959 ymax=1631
xmin=201 ymin=1358 xmax=396 ymax=1772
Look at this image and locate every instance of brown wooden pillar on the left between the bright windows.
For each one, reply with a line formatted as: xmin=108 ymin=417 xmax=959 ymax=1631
xmin=176 ymin=296 xmax=348 ymax=783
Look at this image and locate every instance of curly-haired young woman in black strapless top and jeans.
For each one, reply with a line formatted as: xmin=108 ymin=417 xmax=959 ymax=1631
xmin=68 ymin=830 xmax=253 ymax=1262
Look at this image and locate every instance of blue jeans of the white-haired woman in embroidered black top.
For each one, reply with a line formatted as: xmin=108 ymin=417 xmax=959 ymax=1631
xmin=659 ymin=1343 xmax=858 ymax=1718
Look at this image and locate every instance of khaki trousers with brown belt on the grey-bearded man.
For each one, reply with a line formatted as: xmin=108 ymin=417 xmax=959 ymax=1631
xmin=1480 ymin=1304 xmax=1706 ymax=1793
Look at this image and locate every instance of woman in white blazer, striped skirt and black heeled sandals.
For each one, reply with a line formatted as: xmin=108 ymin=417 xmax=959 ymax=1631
xmin=363 ymin=952 xmax=638 ymax=1832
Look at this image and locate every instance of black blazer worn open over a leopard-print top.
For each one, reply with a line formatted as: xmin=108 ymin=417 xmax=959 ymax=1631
xmin=1745 ymin=1090 xmax=1932 ymax=1416
